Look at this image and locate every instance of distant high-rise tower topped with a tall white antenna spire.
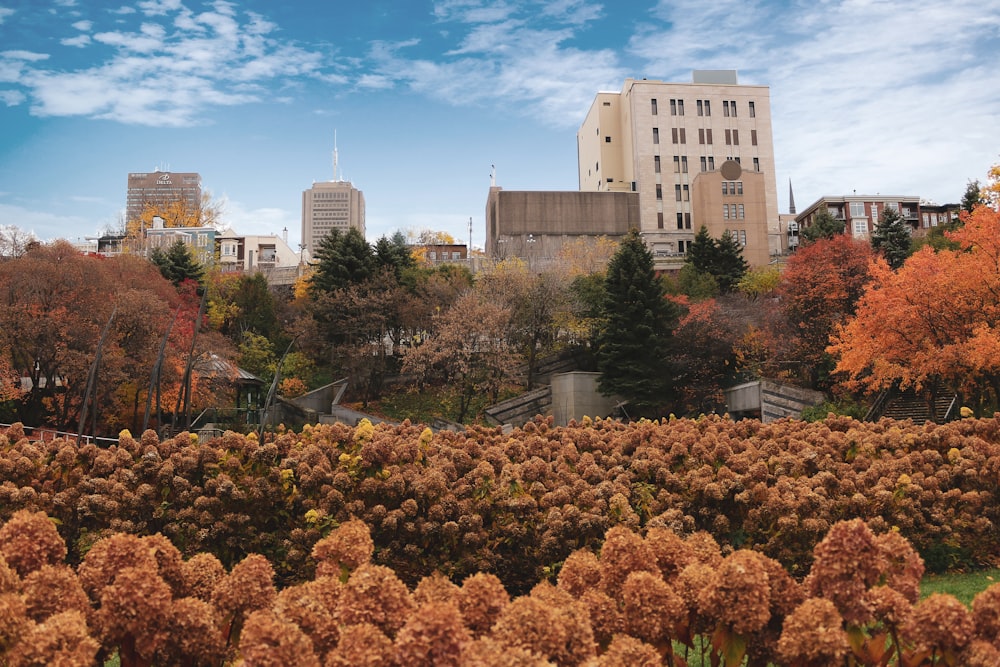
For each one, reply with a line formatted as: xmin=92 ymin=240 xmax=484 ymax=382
xmin=302 ymin=143 xmax=365 ymax=255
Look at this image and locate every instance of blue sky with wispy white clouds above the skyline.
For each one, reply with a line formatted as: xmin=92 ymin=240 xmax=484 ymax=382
xmin=0 ymin=0 xmax=1000 ymax=248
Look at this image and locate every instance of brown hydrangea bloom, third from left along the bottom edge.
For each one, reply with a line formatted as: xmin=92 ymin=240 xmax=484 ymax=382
xmin=153 ymin=597 xmax=226 ymax=667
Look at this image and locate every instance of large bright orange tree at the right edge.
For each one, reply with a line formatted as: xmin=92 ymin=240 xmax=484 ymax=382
xmin=829 ymin=206 xmax=1000 ymax=413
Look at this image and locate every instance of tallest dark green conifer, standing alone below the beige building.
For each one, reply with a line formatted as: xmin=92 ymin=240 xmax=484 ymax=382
xmin=595 ymin=229 xmax=678 ymax=417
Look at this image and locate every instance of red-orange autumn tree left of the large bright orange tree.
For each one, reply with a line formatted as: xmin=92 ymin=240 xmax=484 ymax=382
xmin=778 ymin=234 xmax=872 ymax=389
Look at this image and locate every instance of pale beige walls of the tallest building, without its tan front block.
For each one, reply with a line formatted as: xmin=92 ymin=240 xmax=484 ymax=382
xmin=577 ymin=73 xmax=778 ymax=268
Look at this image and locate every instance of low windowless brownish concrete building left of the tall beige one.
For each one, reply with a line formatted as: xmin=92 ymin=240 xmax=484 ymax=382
xmin=486 ymin=186 xmax=640 ymax=268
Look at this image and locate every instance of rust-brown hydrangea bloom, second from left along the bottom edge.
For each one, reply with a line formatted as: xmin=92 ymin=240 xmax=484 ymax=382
xmin=95 ymin=567 xmax=171 ymax=662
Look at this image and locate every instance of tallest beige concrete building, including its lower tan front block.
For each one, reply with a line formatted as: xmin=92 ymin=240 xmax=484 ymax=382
xmin=577 ymin=70 xmax=780 ymax=269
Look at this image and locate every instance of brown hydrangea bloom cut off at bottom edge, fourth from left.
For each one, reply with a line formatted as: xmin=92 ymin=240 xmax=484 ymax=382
xmin=236 ymin=610 xmax=320 ymax=667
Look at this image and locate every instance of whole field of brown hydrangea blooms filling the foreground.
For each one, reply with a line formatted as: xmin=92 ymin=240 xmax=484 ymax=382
xmin=0 ymin=417 xmax=1000 ymax=666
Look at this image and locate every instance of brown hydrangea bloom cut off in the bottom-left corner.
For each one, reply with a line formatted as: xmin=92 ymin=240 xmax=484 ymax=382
xmin=6 ymin=611 xmax=101 ymax=667
